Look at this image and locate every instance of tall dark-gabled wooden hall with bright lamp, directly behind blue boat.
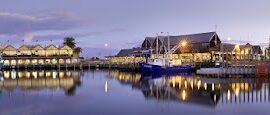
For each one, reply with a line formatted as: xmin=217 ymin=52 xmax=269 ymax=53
xmin=141 ymin=32 xmax=221 ymax=63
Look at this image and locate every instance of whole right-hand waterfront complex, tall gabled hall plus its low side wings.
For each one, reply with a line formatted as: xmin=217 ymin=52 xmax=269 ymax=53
xmin=113 ymin=32 xmax=267 ymax=63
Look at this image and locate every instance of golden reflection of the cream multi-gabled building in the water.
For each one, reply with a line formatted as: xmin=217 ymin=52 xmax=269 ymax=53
xmin=0 ymin=70 xmax=81 ymax=95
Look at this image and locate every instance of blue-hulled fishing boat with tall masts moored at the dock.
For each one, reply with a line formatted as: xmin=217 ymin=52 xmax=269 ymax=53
xmin=139 ymin=32 xmax=192 ymax=73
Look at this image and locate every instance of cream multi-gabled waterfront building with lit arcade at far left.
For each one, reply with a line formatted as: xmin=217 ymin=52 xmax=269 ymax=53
xmin=1 ymin=44 xmax=80 ymax=66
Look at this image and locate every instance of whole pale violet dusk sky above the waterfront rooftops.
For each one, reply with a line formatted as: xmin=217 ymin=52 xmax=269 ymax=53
xmin=0 ymin=0 xmax=270 ymax=55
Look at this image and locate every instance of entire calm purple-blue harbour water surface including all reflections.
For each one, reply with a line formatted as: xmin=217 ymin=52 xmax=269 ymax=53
xmin=0 ymin=70 xmax=270 ymax=115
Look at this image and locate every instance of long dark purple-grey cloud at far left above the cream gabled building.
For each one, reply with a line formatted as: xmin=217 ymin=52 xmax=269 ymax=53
xmin=0 ymin=12 xmax=84 ymax=35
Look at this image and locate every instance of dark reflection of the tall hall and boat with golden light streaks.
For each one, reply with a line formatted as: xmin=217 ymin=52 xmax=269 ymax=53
xmin=109 ymin=71 xmax=269 ymax=107
